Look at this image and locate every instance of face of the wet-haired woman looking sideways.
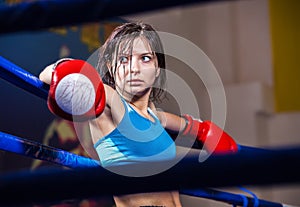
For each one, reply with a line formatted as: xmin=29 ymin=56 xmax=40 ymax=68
xmin=115 ymin=37 xmax=160 ymax=98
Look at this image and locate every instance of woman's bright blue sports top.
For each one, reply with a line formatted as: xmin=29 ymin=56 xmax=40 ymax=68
xmin=94 ymin=99 xmax=176 ymax=167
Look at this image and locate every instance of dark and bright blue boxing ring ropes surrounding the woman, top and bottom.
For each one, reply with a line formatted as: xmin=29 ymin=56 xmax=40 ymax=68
xmin=0 ymin=0 xmax=300 ymax=207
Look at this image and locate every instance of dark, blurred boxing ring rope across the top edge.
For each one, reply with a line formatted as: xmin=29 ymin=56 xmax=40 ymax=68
xmin=0 ymin=0 xmax=216 ymax=34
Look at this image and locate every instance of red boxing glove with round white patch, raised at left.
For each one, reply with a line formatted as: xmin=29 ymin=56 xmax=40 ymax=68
xmin=47 ymin=59 xmax=105 ymax=121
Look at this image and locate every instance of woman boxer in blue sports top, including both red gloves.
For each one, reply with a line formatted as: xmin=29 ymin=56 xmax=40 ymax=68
xmin=40 ymin=23 xmax=238 ymax=207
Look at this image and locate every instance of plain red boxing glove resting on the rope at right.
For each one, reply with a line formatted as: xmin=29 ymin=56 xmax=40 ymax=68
xmin=182 ymin=114 xmax=238 ymax=154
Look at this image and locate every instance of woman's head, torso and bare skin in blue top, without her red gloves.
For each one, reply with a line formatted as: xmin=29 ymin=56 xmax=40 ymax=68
xmin=40 ymin=23 xmax=185 ymax=207
